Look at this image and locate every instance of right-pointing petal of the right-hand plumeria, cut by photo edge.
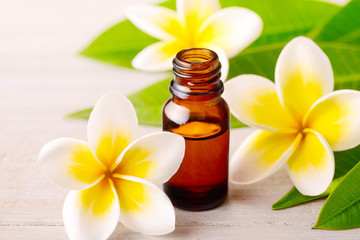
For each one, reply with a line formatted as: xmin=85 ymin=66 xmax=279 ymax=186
xmin=304 ymin=90 xmax=360 ymax=151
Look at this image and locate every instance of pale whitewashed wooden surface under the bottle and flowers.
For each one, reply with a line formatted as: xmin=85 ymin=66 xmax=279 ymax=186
xmin=0 ymin=0 xmax=360 ymax=240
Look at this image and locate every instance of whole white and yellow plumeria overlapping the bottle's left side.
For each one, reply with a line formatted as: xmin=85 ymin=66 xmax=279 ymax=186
xmin=38 ymin=93 xmax=185 ymax=240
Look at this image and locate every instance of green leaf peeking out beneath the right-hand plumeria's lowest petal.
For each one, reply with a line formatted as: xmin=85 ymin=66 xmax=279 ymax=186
xmin=272 ymin=146 xmax=360 ymax=210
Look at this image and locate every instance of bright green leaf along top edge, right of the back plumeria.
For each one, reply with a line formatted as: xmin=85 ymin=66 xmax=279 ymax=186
xmin=221 ymin=0 xmax=341 ymax=48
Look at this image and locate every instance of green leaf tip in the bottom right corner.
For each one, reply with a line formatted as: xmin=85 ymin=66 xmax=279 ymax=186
xmin=314 ymin=159 xmax=360 ymax=230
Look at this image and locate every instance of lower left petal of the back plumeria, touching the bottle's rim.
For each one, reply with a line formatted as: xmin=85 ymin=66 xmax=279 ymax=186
xmin=131 ymin=41 xmax=187 ymax=72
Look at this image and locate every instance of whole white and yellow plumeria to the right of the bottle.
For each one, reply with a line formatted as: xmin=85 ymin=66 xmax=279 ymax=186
xmin=224 ymin=37 xmax=360 ymax=195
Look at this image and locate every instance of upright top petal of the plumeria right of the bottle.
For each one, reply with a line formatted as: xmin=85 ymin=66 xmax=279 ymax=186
xmin=275 ymin=37 xmax=334 ymax=120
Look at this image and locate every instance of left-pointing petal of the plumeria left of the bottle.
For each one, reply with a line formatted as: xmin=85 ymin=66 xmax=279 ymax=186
xmin=38 ymin=138 xmax=104 ymax=190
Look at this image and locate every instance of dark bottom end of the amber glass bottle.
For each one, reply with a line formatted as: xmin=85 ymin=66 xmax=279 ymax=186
xmin=164 ymin=180 xmax=228 ymax=211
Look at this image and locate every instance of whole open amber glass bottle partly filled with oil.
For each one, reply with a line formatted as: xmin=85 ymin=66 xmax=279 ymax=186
xmin=163 ymin=48 xmax=229 ymax=211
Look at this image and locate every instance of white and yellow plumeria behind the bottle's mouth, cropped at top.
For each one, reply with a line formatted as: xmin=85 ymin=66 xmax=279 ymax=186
xmin=126 ymin=0 xmax=263 ymax=81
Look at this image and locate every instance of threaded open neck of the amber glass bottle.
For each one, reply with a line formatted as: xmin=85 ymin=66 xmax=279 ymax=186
xmin=170 ymin=48 xmax=224 ymax=100
